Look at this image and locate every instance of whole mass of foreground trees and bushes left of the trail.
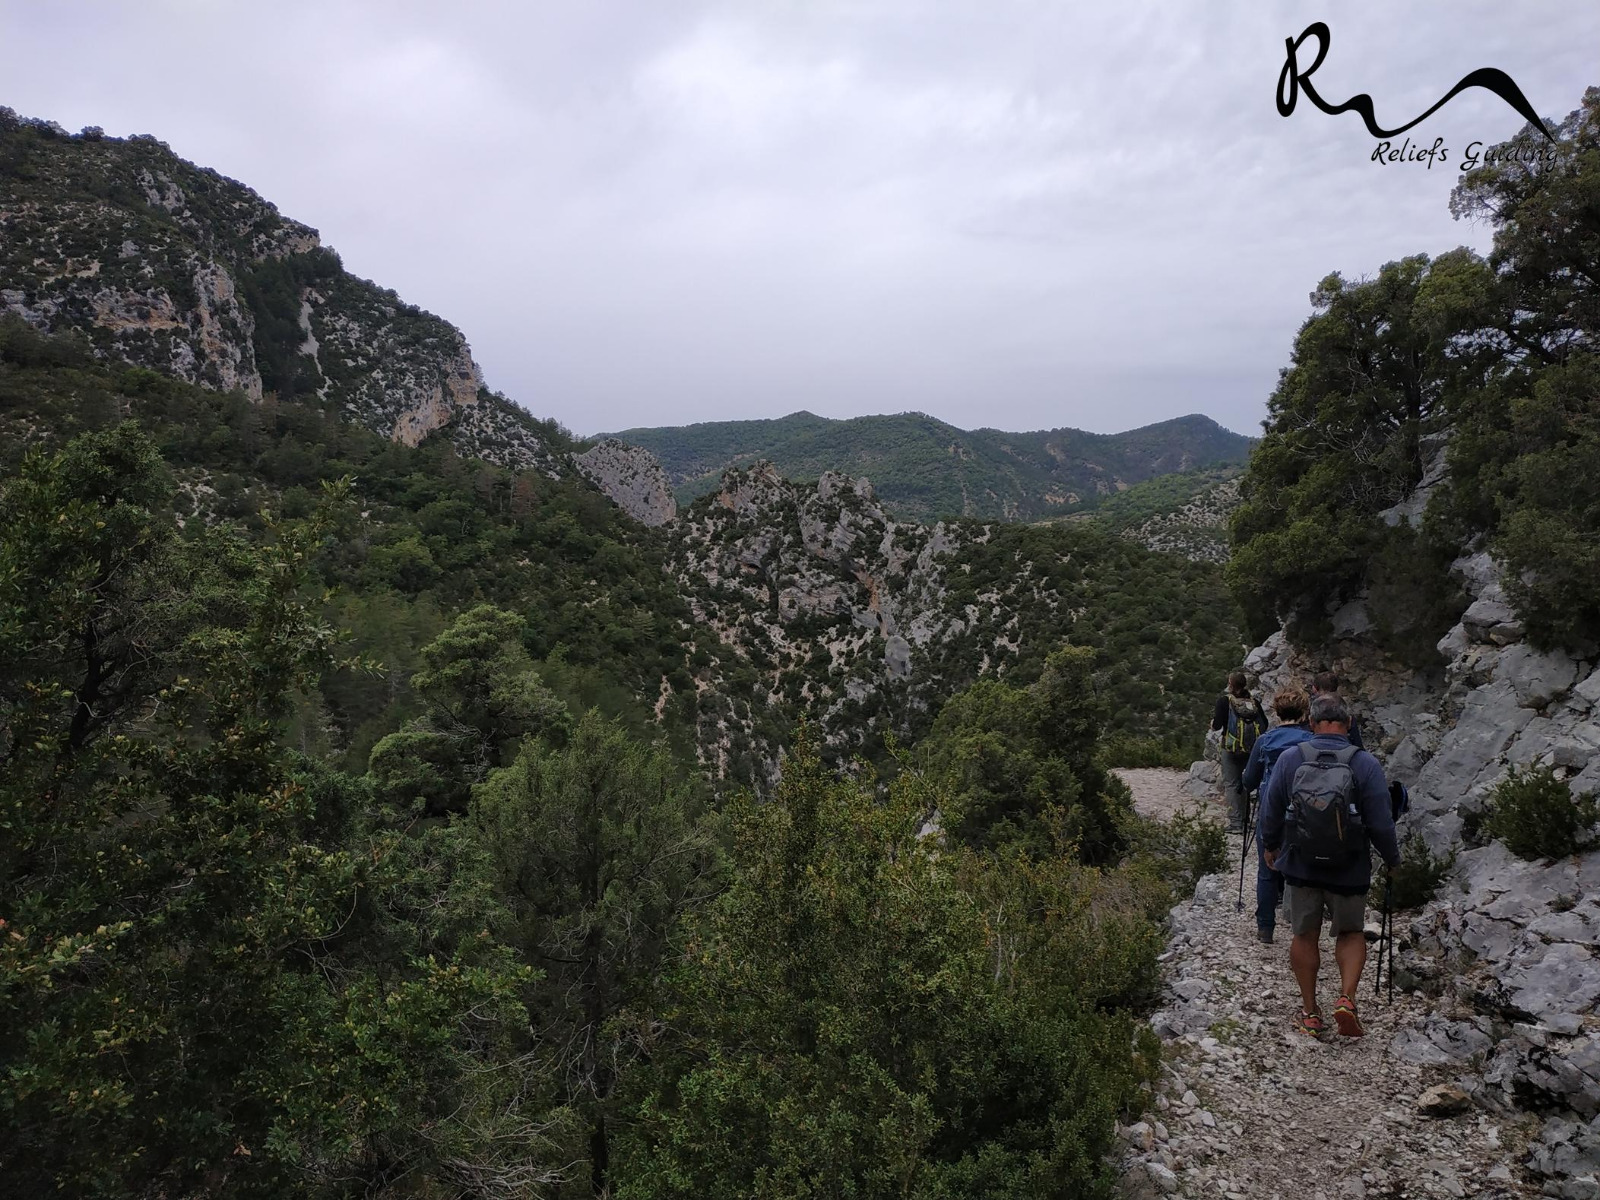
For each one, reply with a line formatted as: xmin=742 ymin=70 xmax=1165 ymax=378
xmin=0 ymin=412 xmax=1209 ymax=1197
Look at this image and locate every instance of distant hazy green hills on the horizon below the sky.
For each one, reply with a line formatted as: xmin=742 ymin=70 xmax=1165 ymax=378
xmin=611 ymin=413 xmax=1253 ymax=520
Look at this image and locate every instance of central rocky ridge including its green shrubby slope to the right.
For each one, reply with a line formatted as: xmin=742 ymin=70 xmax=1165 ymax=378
xmin=669 ymin=464 xmax=1237 ymax=790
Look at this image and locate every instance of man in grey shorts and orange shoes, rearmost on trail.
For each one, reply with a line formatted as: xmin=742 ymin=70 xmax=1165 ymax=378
xmin=1261 ymin=691 xmax=1400 ymax=1037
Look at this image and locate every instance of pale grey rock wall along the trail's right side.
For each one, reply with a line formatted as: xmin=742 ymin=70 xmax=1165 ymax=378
xmin=1209 ymin=554 xmax=1600 ymax=1197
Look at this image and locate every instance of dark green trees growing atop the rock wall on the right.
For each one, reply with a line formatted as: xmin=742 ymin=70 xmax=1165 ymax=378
xmin=1229 ymin=90 xmax=1600 ymax=662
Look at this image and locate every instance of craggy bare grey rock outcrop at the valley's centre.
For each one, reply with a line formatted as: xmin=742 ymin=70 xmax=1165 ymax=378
xmin=672 ymin=462 xmax=953 ymax=776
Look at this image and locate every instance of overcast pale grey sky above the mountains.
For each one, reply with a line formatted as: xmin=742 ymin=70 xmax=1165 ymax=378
xmin=0 ymin=0 xmax=1600 ymax=434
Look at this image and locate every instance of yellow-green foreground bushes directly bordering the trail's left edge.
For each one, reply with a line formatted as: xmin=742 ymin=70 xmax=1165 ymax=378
xmin=621 ymin=736 xmax=1166 ymax=1200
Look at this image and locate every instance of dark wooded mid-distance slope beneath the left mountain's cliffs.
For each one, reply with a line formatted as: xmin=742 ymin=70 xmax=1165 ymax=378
xmin=0 ymin=320 xmax=686 ymax=766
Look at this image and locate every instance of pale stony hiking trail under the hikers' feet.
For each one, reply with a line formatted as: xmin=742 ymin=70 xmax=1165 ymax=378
xmin=1118 ymin=768 xmax=1541 ymax=1200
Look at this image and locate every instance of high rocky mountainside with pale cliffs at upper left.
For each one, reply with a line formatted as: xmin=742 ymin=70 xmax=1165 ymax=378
xmin=0 ymin=109 xmax=558 ymax=474
